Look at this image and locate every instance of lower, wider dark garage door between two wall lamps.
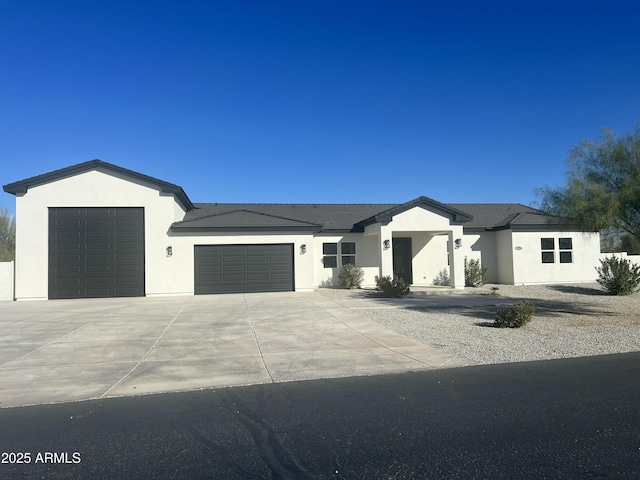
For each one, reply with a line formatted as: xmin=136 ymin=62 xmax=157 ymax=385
xmin=195 ymin=243 xmax=294 ymax=294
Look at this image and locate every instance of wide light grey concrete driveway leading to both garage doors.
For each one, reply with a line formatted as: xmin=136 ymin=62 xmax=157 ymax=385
xmin=0 ymin=292 xmax=473 ymax=407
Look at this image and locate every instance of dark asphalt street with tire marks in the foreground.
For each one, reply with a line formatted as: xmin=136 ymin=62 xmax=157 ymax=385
xmin=0 ymin=353 xmax=640 ymax=479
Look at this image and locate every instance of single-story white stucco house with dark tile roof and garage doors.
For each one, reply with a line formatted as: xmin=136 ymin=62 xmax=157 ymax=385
xmin=3 ymin=160 xmax=600 ymax=300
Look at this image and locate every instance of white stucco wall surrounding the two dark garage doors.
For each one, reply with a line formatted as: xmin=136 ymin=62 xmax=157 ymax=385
xmin=15 ymin=170 xmax=313 ymax=300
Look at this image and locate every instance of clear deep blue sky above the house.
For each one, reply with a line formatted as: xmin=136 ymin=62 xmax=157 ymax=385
xmin=0 ymin=0 xmax=640 ymax=211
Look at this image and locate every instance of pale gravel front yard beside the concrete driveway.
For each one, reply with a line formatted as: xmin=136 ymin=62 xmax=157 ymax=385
xmin=325 ymin=283 xmax=640 ymax=364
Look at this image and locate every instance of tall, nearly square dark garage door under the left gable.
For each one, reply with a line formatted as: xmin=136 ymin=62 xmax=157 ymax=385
xmin=49 ymin=208 xmax=144 ymax=299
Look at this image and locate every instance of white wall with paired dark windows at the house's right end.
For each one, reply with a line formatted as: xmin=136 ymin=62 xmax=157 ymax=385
xmin=511 ymin=231 xmax=600 ymax=285
